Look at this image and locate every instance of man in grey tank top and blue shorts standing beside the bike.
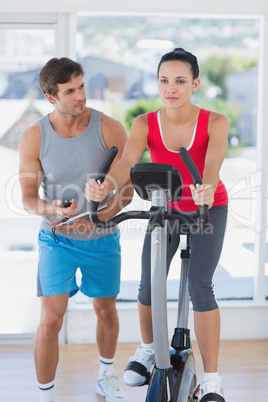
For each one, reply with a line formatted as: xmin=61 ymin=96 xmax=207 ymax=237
xmin=19 ymin=57 xmax=133 ymax=402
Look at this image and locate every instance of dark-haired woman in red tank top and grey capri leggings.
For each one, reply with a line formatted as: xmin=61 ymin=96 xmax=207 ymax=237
xmin=85 ymin=48 xmax=229 ymax=402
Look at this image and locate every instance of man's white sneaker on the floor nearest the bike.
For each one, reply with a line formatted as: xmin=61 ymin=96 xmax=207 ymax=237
xmin=96 ymin=370 xmax=129 ymax=402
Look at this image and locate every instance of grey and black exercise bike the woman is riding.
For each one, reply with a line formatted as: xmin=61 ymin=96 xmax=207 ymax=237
xmin=89 ymin=147 xmax=209 ymax=402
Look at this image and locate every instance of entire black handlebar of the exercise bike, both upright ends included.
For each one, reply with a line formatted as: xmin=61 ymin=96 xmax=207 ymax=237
xmin=89 ymin=146 xmax=209 ymax=233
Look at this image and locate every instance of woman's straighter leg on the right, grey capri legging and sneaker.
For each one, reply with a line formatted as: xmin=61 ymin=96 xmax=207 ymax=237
xmin=189 ymin=207 xmax=227 ymax=401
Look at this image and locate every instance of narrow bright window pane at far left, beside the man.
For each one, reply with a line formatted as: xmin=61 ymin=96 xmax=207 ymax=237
xmin=0 ymin=25 xmax=54 ymax=334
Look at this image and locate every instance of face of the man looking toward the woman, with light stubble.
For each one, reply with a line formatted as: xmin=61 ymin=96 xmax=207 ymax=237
xmin=50 ymin=75 xmax=86 ymax=116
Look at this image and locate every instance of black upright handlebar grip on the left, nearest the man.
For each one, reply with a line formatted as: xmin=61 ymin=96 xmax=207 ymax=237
xmin=89 ymin=145 xmax=118 ymax=227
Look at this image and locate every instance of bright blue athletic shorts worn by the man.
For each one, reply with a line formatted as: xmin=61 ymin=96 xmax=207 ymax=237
xmin=37 ymin=230 xmax=121 ymax=297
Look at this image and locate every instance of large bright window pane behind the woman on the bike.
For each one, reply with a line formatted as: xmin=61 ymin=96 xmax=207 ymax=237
xmin=77 ymin=15 xmax=259 ymax=300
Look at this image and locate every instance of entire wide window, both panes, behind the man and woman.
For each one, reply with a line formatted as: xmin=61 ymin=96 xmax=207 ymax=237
xmin=0 ymin=14 xmax=268 ymax=342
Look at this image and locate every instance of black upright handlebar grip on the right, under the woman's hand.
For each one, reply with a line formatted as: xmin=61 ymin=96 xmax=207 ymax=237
xmin=179 ymin=147 xmax=209 ymax=233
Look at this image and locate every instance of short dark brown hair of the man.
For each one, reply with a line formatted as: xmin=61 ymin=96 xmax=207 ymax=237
xmin=39 ymin=57 xmax=84 ymax=96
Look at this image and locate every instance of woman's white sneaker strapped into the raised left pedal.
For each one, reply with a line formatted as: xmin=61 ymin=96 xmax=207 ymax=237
xmin=124 ymin=345 xmax=155 ymax=387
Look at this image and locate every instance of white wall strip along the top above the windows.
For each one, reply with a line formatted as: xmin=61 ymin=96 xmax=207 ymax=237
xmin=0 ymin=0 xmax=268 ymax=17
